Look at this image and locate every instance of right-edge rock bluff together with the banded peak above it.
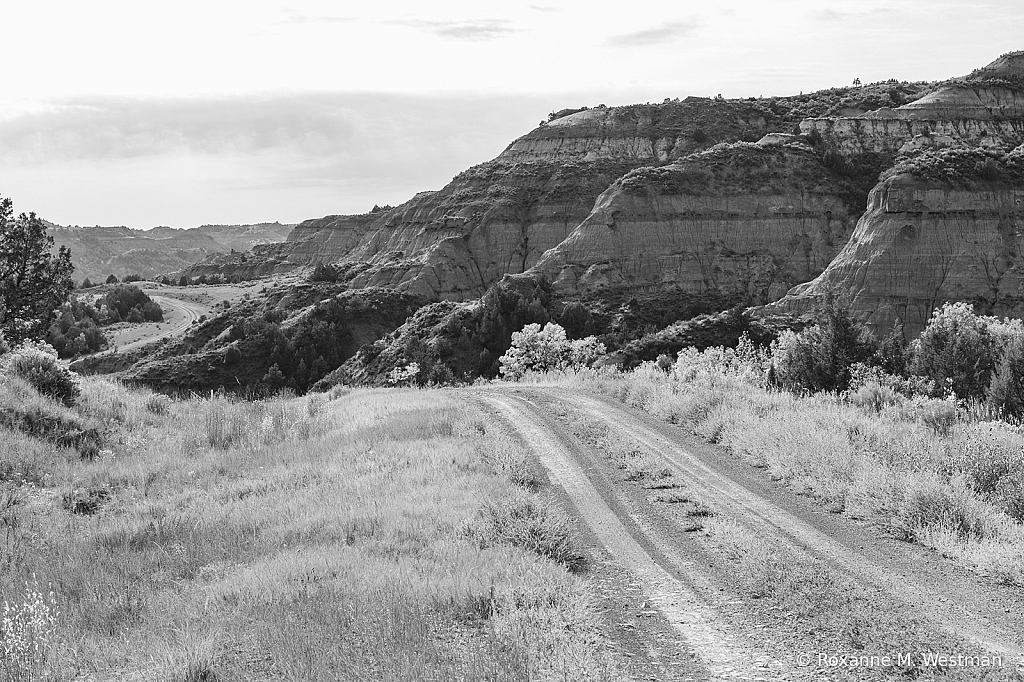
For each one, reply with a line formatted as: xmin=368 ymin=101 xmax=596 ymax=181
xmin=773 ymin=52 xmax=1024 ymax=338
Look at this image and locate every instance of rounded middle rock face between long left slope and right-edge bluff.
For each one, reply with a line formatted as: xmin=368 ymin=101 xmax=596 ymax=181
xmin=531 ymin=141 xmax=858 ymax=303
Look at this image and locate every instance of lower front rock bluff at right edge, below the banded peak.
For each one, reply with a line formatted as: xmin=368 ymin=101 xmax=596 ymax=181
xmin=775 ymin=150 xmax=1024 ymax=338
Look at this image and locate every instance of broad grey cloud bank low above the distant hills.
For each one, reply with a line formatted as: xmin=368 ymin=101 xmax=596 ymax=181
xmin=0 ymin=92 xmax=552 ymax=191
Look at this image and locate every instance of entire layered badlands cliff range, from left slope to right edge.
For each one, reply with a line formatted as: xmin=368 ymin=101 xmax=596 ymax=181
xmin=180 ymin=53 xmax=1024 ymax=339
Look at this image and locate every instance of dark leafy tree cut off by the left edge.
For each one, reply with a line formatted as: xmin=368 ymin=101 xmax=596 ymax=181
xmin=0 ymin=199 xmax=75 ymax=345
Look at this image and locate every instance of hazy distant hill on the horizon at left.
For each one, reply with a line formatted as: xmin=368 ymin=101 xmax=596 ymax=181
xmin=47 ymin=222 xmax=294 ymax=282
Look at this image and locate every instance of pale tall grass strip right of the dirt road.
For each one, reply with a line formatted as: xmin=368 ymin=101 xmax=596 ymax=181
xmin=552 ymin=348 xmax=1024 ymax=585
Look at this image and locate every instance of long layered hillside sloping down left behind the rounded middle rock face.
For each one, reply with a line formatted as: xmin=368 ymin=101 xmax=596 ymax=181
xmin=184 ymin=83 xmax=927 ymax=300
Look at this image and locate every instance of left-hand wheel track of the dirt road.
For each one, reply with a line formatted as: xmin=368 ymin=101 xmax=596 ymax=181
xmin=483 ymin=394 xmax=792 ymax=680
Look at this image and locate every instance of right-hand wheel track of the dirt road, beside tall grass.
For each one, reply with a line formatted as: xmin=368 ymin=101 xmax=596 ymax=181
xmin=515 ymin=387 xmax=1024 ymax=666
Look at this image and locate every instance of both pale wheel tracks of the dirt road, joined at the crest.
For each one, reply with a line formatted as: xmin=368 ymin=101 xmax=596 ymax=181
xmin=477 ymin=386 xmax=1024 ymax=678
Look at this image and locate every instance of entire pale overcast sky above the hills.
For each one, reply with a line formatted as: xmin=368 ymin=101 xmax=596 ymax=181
xmin=0 ymin=0 xmax=1024 ymax=227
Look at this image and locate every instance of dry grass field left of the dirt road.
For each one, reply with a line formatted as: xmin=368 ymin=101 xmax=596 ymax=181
xmin=0 ymin=376 xmax=617 ymax=682
